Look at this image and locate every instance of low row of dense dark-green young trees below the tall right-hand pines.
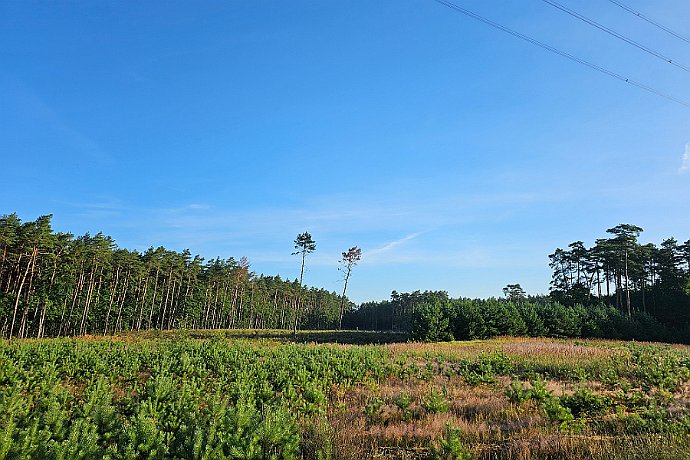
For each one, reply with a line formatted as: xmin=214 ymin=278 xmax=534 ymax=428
xmin=346 ymin=291 xmax=690 ymax=343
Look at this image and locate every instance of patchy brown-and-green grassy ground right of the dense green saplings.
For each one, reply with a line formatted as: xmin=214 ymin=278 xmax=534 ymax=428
xmin=329 ymin=338 xmax=690 ymax=459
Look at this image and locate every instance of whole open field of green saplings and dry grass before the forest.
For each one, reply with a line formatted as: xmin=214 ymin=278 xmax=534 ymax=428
xmin=0 ymin=331 xmax=690 ymax=459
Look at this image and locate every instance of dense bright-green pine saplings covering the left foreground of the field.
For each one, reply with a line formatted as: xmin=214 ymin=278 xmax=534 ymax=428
xmin=0 ymin=338 xmax=393 ymax=459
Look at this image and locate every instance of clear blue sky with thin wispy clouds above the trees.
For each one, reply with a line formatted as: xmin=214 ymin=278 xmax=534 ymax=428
xmin=0 ymin=0 xmax=690 ymax=302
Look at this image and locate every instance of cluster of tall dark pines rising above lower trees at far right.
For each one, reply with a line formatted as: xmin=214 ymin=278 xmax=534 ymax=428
xmin=549 ymin=224 xmax=690 ymax=325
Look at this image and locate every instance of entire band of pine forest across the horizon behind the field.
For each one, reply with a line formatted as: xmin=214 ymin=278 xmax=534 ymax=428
xmin=0 ymin=214 xmax=690 ymax=342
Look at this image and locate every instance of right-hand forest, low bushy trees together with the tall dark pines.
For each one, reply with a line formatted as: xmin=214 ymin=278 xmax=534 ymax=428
xmin=345 ymin=224 xmax=690 ymax=343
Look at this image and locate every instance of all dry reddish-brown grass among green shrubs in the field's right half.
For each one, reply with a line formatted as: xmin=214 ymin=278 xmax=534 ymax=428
xmin=318 ymin=338 xmax=690 ymax=460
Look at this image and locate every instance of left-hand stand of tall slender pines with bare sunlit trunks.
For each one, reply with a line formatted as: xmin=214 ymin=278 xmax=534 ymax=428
xmin=0 ymin=214 xmax=344 ymax=338
